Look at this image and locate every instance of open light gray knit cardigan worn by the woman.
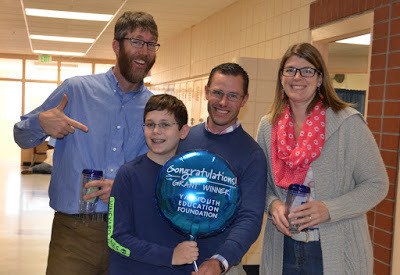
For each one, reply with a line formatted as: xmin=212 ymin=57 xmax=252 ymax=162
xmin=257 ymin=108 xmax=389 ymax=275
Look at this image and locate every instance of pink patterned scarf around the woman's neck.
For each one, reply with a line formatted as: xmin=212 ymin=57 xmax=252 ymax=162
xmin=271 ymin=102 xmax=325 ymax=189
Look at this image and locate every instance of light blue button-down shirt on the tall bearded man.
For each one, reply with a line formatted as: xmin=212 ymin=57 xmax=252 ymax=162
xmin=14 ymin=69 xmax=152 ymax=214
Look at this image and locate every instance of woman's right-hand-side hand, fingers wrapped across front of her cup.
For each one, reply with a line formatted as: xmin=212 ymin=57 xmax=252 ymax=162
xmin=289 ymin=201 xmax=330 ymax=231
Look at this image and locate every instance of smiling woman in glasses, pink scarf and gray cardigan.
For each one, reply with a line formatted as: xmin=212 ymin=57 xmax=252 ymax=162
xmin=257 ymin=43 xmax=388 ymax=274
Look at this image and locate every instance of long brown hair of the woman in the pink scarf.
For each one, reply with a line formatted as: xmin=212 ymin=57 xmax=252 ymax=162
xmin=268 ymin=43 xmax=352 ymax=124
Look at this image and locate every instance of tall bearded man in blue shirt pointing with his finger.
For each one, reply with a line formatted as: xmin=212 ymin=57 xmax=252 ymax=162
xmin=14 ymin=12 xmax=160 ymax=275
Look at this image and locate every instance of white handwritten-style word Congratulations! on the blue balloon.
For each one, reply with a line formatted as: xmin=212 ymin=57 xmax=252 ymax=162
xmin=167 ymin=165 xmax=237 ymax=185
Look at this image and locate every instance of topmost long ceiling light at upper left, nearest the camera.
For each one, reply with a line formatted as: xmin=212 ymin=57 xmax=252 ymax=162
xmin=25 ymin=9 xmax=112 ymax=21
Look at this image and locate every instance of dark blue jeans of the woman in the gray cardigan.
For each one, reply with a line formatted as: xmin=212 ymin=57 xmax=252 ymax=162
xmin=282 ymin=236 xmax=323 ymax=275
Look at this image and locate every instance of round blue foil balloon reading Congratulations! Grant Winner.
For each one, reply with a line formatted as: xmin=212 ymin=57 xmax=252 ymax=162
xmin=155 ymin=150 xmax=240 ymax=238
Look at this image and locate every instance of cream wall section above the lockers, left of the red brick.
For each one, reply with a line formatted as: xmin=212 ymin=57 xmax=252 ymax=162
xmin=152 ymin=0 xmax=313 ymax=85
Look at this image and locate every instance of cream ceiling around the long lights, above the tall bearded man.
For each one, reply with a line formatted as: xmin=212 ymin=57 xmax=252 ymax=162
xmin=0 ymin=0 xmax=236 ymax=59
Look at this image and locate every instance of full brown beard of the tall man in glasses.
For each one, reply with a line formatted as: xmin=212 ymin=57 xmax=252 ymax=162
xmin=118 ymin=47 xmax=156 ymax=83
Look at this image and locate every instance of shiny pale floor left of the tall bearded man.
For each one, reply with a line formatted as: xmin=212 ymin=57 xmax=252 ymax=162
xmin=0 ymin=158 xmax=54 ymax=275
